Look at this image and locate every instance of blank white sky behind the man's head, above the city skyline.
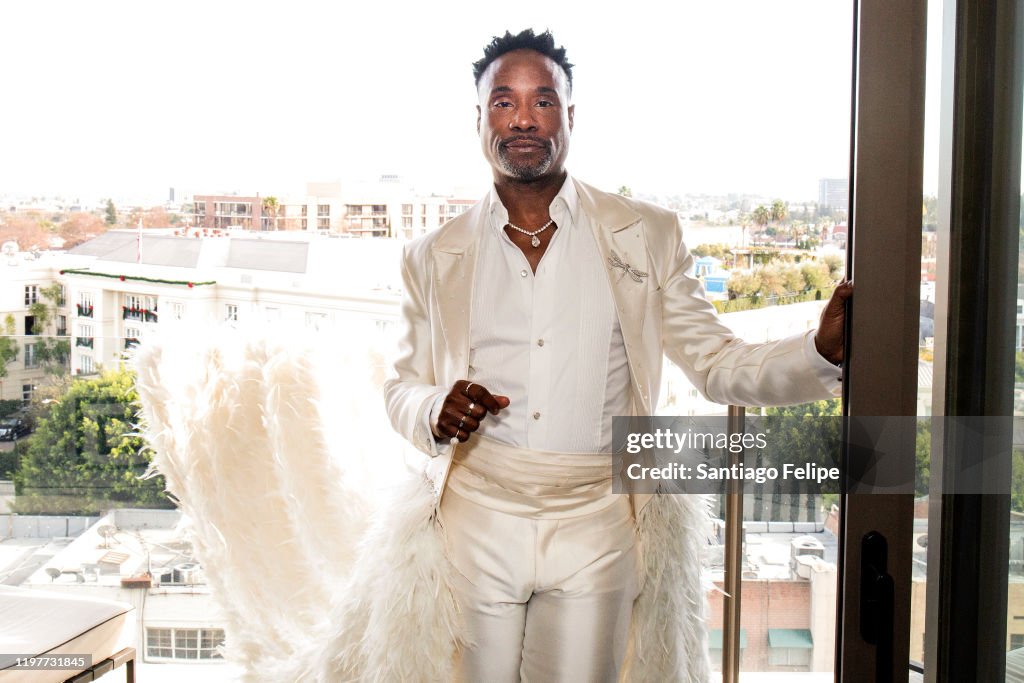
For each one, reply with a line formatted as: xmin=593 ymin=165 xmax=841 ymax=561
xmin=0 ymin=0 xmax=954 ymax=202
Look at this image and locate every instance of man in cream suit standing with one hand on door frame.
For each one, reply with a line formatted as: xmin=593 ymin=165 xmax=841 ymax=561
xmin=385 ymin=30 xmax=852 ymax=683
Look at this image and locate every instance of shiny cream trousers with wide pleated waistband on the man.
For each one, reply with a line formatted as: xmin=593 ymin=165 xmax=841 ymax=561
xmin=440 ymin=436 xmax=642 ymax=683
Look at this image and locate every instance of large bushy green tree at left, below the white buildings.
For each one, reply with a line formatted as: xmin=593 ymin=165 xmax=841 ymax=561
xmin=14 ymin=370 xmax=174 ymax=514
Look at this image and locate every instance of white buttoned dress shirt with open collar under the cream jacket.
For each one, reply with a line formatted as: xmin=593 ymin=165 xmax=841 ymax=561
xmin=430 ymin=177 xmax=630 ymax=453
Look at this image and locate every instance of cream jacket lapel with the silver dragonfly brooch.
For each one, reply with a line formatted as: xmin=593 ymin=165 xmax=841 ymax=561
xmin=575 ymin=180 xmax=652 ymax=415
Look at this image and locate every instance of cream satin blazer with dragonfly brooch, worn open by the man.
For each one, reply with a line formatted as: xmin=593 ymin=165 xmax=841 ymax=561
xmin=384 ymin=180 xmax=842 ymax=511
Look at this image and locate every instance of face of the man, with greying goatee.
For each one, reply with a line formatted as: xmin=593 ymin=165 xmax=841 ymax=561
xmin=476 ymin=50 xmax=573 ymax=182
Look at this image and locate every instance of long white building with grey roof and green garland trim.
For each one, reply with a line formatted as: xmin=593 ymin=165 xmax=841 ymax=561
xmin=55 ymin=230 xmax=400 ymax=375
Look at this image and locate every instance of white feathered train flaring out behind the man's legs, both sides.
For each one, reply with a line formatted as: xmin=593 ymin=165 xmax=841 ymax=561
xmin=132 ymin=329 xmax=710 ymax=683
